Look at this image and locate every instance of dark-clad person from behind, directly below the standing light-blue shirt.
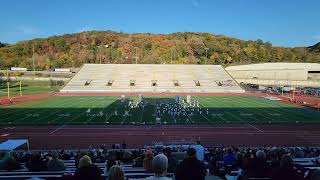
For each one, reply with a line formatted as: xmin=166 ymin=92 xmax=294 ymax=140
xmin=175 ymin=148 xmax=206 ymax=180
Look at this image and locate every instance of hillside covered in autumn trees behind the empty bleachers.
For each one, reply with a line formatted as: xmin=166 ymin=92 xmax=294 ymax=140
xmin=0 ymin=31 xmax=320 ymax=70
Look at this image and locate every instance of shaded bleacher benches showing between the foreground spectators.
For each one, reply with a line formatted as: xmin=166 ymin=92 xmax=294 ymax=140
xmin=0 ymin=147 xmax=320 ymax=180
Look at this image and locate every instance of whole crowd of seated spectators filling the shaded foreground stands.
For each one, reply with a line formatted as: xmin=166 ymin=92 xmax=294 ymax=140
xmin=0 ymin=142 xmax=320 ymax=180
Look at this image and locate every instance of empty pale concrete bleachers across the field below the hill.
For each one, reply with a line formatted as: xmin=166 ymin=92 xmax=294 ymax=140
xmin=61 ymin=64 xmax=244 ymax=93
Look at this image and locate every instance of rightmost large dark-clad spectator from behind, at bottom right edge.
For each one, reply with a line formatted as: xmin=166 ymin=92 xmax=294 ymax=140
xmin=271 ymin=155 xmax=303 ymax=180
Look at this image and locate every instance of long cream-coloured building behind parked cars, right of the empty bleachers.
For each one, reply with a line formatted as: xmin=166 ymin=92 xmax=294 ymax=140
xmin=225 ymin=63 xmax=320 ymax=87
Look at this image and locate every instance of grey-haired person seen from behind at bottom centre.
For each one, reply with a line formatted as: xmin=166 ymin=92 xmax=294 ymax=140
xmin=147 ymin=154 xmax=170 ymax=180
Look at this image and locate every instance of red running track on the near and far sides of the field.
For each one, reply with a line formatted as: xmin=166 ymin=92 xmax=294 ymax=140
xmin=0 ymin=93 xmax=320 ymax=149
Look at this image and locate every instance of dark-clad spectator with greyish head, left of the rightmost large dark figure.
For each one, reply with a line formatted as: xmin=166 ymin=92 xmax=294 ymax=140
xmin=247 ymin=150 xmax=270 ymax=178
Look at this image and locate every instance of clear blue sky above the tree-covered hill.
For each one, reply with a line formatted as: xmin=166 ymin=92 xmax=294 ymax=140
xmin=0 ymin=0 xmax=320 ymax=47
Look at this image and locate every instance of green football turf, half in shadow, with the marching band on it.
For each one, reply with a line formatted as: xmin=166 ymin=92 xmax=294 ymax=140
xmin=0 ymin=96 xmax=320 ymax=125
